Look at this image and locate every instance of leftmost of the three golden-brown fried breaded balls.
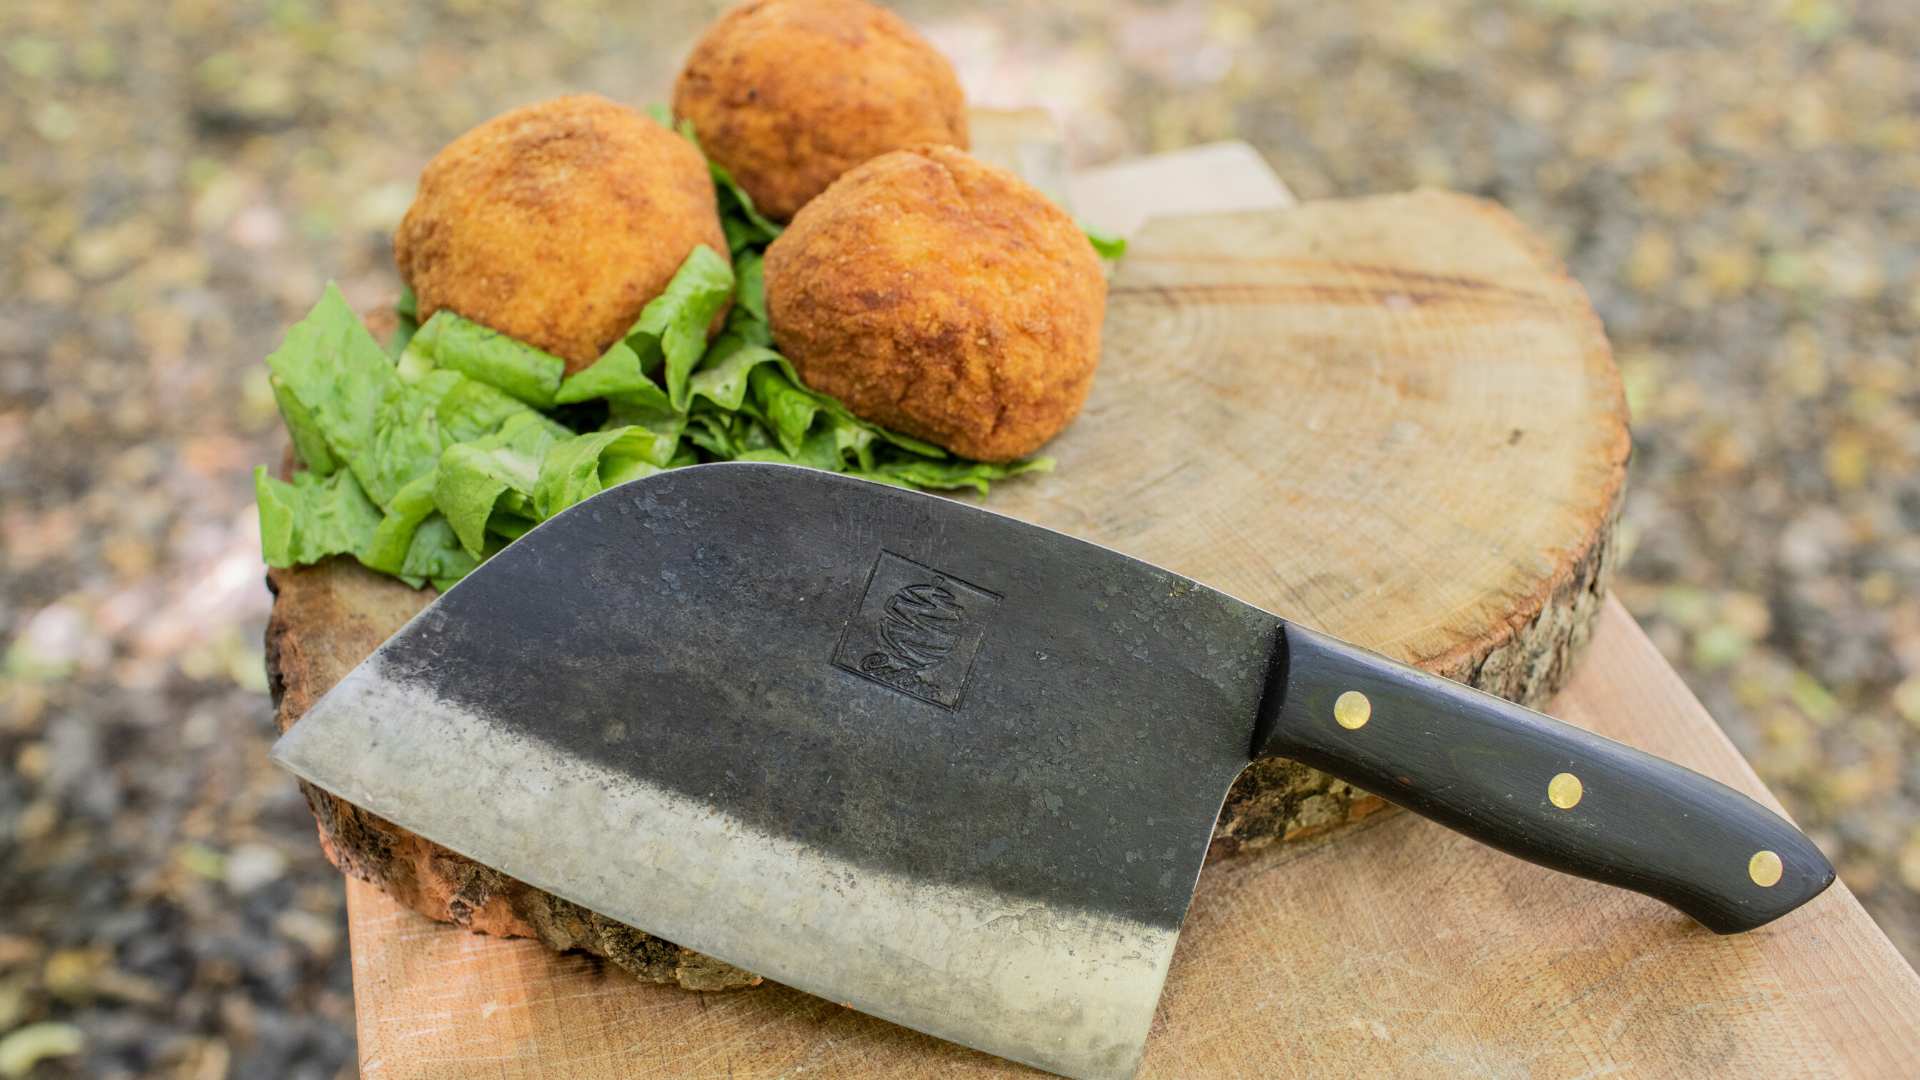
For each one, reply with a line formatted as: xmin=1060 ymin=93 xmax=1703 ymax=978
xmin=394 ymin=94 xmax=728 ymax=375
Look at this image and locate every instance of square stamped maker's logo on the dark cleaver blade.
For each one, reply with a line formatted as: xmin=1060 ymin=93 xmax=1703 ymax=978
xmin=833 ymin=552 xmax=1000 ymax=709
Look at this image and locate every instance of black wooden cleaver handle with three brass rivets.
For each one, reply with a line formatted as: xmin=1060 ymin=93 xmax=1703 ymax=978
xmin=1254 ymin=623 xmax=1834 ymax=934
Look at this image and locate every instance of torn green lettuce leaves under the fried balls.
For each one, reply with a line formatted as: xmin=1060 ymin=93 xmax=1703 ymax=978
xmin=253 ymin=135 xmax=1059 ymax=588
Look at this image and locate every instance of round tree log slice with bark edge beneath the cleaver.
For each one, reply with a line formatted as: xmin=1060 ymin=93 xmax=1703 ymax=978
xmin=267 ymin=192 xmax=1628 ymax=990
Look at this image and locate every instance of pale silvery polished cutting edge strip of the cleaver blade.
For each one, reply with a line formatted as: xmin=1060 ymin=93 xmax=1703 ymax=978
xmin=271 ymin=653 xmax=1179 ymax=1080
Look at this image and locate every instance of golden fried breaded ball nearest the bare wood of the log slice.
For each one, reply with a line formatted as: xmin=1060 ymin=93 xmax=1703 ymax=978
xmin=766 ymin=146 xmax=1106 ymax=461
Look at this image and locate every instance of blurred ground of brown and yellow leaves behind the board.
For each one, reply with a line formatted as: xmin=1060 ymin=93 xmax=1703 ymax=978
xmin=0 ymin=0 xmax=1920 ymax=1080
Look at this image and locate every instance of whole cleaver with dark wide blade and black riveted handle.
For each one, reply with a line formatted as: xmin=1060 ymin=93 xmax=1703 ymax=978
xmin=273 ymin=463 xmax=1834 ymax=1080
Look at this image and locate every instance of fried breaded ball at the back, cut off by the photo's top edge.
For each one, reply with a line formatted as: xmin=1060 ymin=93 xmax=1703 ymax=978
xmin=674 ymin=0 xmax=968 ymax=221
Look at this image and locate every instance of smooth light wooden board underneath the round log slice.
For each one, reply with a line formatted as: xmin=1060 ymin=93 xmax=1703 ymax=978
xmin=348 ymin=603 xmax=1920 ymax=1080
